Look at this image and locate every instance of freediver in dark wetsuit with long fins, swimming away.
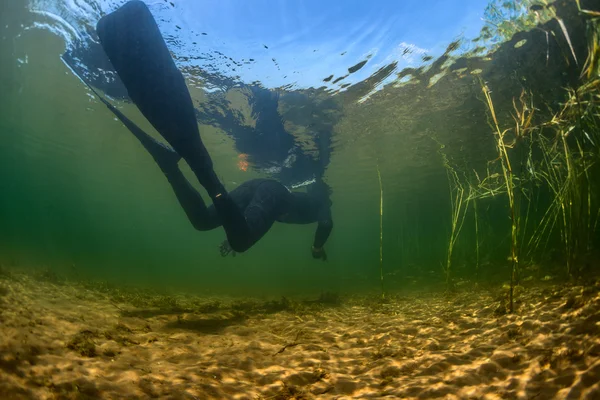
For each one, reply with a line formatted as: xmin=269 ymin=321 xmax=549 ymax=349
xmin=90 ymin=0 xmax=333 ymax=260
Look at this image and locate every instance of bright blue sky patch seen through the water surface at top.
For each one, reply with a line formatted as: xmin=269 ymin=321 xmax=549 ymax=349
xmin=154 ymin=0 xmax=487 ymax=88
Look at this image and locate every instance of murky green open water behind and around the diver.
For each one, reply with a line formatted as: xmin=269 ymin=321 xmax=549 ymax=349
xmin=0 ymin=2 xmax=598 ymax=295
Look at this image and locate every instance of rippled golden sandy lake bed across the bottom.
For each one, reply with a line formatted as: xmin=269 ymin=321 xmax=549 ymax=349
xmin=0 ymin=273 xmax=600 ymax=399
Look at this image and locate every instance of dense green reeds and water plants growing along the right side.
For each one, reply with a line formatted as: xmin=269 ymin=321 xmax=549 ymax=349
xmin=438 ymin=5 xmax=600 ymax=312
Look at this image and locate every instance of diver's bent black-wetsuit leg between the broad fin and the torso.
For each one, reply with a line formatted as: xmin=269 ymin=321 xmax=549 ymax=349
xmin=221 ymin=180 xmax=292 ymax=252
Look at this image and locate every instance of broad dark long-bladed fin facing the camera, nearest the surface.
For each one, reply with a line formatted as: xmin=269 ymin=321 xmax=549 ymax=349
xmin=96 ymin=0 xmax=224 ymax=198
